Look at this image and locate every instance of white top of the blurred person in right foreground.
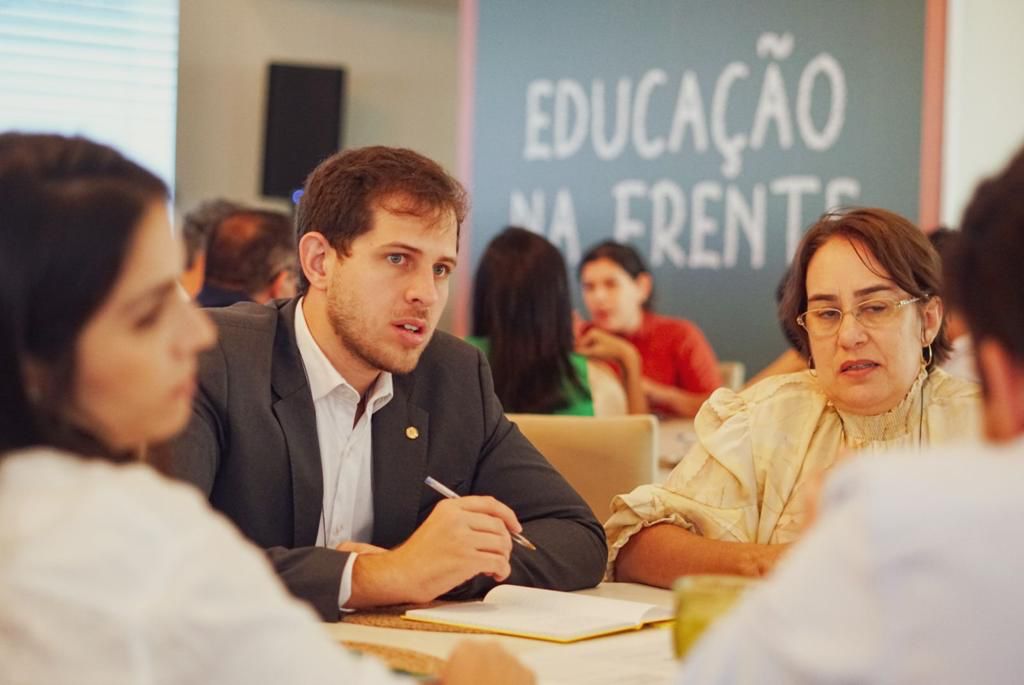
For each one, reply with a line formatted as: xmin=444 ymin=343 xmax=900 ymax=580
xmin=676 ymin=440 xmax=1024 ymax=685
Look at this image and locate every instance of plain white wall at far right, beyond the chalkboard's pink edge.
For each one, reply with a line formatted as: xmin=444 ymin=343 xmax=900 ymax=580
xmin=941 ymin=0 xmax=1024 ymax=226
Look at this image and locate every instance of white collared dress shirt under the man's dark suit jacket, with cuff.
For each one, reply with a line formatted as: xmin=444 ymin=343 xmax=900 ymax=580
xmin=295 ymin=298 xmax=394 ymax=607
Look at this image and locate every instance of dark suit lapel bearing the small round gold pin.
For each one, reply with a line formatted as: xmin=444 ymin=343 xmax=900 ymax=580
xmin=373 ymin=375 xmax=430 ymax=548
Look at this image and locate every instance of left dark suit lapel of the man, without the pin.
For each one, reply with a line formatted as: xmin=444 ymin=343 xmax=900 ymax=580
xmin=270 ymin=299 xmax=324 ymax=547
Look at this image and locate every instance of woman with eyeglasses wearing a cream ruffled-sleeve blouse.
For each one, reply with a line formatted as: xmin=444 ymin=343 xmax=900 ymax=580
xmin=605 ymin=209 xmax=981 ymax=587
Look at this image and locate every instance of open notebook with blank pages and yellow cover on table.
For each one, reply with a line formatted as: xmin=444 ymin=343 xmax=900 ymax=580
xmin=404 ymin=585 xmax=672 ymax=642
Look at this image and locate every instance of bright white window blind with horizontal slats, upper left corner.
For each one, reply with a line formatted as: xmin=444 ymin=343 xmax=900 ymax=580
xmin=0 ymin=0 xmax=178 ymax=185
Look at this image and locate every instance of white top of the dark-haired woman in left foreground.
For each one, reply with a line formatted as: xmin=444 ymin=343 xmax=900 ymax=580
xmin=0 ymin=449 xmax=404 ymax=685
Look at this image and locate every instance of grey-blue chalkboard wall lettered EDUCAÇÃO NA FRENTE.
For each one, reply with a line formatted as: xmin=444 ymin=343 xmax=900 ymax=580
xmin=470 ymin=0 xmax=925 ymax=373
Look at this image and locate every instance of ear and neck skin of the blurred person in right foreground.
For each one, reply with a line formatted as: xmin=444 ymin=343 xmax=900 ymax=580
xmin=976 ymin=339 xmax=1024 ymax=442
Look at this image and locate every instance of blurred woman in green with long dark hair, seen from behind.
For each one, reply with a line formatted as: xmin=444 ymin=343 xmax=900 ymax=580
xmin=467 ymin=227 xmax=647 ymax=416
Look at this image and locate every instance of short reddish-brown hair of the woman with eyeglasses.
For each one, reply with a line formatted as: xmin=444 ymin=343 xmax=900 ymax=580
xmin=778 ymin=207 xmax=951 ymax=371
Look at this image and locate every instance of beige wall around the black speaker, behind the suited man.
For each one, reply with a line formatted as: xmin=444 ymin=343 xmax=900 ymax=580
xmin=175 ymin=0 xmax=458 ymax=212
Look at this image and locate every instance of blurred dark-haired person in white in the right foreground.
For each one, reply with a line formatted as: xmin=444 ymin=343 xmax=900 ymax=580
xmin=677 ymin=144 xmax=1024 ymax=685
